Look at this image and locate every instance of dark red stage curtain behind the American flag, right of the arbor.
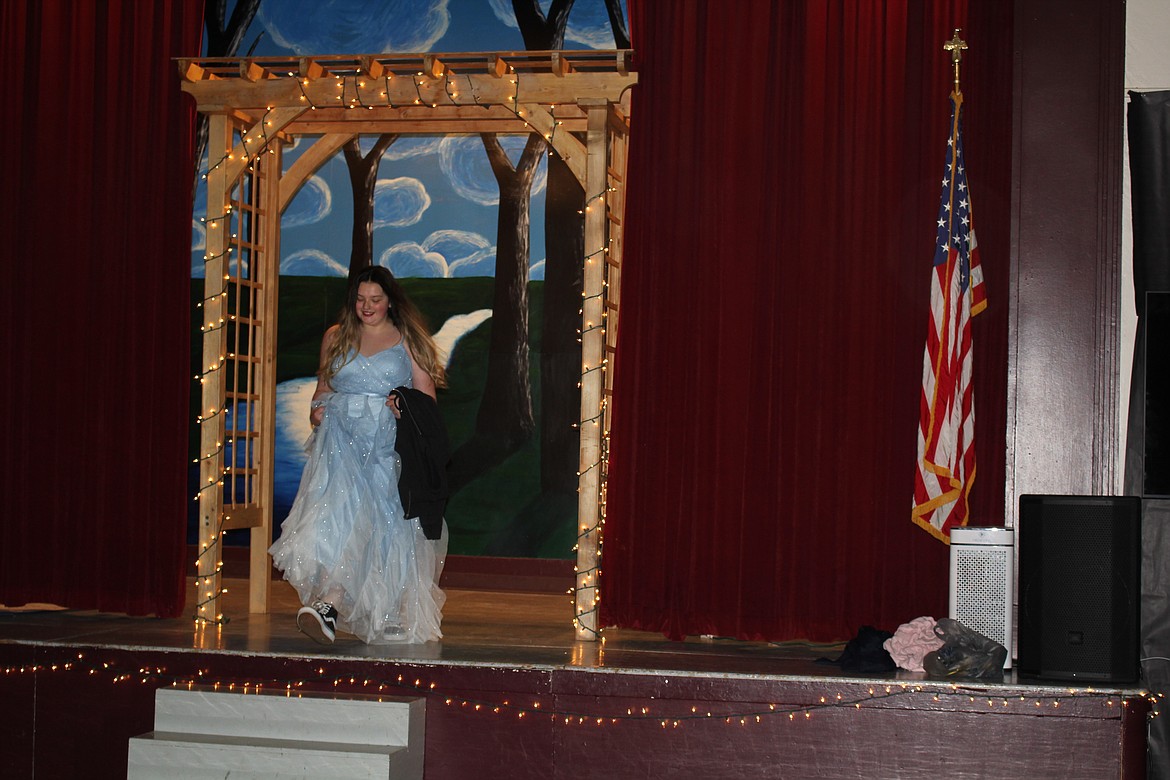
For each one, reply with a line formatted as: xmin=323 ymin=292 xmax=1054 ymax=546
xmin=600 ymin=0 xmax=1012 ymax=641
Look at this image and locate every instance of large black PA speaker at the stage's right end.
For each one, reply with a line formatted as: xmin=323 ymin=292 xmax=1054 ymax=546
xmin=1017 ymin=496 xmax=1142 ymax=682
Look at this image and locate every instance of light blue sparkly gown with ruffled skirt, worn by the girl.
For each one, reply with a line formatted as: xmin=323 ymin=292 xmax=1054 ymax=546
xmin=269 ymin=341 xmax=447 ymax=644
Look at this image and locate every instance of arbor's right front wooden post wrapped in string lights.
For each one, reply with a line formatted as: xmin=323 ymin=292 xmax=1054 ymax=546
xmin=574 ymin=102 xmax=610 ymax=641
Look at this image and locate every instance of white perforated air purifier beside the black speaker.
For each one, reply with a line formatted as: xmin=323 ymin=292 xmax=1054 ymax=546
xmin=949 ymin=527 xmax=1016 ymax=669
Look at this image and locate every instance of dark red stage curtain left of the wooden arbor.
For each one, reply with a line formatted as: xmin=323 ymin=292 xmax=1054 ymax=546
xmin=0 ymin=0 xmax=204 ymax=616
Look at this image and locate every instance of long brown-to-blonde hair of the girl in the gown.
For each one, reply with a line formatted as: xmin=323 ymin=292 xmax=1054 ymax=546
xmin=317 ymin=265 xmax=447 ymax=387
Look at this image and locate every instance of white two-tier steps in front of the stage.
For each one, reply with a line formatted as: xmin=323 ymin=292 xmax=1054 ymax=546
xmin=126 ymin=688 xmax=426 ymax=780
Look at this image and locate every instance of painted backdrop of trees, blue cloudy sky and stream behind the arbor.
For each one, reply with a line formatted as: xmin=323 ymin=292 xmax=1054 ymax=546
xmin=191 ymin=0 xmax=625 ymax=558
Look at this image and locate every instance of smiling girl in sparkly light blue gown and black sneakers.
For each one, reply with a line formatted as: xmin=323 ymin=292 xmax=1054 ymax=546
xmin=269 ymin=265 xmax=447 ymax=644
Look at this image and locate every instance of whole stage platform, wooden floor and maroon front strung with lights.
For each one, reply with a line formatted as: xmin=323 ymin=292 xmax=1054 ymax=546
xmin=0 ymin=570 xmax=1149 ymax=780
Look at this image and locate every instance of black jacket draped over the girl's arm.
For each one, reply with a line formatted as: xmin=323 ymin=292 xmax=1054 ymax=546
xmin=394 ymin=387 xmax=450 ymax=539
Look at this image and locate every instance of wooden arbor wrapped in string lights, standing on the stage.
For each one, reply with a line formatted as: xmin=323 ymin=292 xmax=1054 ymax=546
xmin=179 ymin=50 xmax=636 ymax=640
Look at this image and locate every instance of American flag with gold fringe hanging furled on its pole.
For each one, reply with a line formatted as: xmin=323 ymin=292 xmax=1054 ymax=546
xmin=913 ymin=91 xmax=987 ymax=544
